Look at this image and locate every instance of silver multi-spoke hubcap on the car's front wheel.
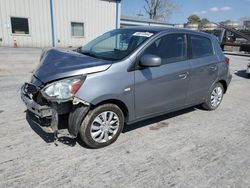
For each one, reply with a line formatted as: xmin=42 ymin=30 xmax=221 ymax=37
xmin=90 ymin=111 xmax=119 ymax=143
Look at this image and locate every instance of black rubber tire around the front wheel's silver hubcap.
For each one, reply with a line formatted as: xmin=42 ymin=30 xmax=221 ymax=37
xmin=79 ymin=104 xmax=124 ymax=148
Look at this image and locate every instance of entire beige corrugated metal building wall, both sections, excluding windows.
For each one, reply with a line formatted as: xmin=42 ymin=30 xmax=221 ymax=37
xmin=0 ymin=0 xmax=121 ymax=47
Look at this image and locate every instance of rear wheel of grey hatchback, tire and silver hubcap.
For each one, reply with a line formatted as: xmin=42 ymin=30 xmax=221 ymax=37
xmin=202 ymin=83 xmax=224 ymax=110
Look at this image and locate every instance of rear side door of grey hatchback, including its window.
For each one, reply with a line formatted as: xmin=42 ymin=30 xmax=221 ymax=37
xmin=187 ymin=35 xmax=218 ymax=104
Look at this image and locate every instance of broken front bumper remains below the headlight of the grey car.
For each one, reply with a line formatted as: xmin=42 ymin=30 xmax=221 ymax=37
xmin=21 ymin=83 xmax=90 ymax=137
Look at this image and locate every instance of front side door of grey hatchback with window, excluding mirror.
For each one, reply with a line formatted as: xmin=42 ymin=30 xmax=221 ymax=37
xmin=135 ymin=34 xmax=190 ymax=118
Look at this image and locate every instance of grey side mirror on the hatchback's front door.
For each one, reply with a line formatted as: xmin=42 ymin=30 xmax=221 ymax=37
xmin=139 ymin=54 xmax=161 ymax=67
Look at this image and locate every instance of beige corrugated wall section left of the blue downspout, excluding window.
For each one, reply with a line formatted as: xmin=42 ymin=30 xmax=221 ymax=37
xmin=0 ymin=0 xmax=51 ymax=47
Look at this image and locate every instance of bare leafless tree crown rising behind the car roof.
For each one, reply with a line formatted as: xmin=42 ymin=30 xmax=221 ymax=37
xmin=144 ymin=0 xmax=176 ymax=21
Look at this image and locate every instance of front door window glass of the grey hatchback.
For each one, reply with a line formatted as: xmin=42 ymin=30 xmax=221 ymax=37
xmin=143 ymin=34 xmax=187 ymax=64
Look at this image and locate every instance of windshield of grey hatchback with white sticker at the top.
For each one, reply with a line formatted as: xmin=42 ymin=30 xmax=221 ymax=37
xmin=80 ymin=29 xmax=154 ymax=60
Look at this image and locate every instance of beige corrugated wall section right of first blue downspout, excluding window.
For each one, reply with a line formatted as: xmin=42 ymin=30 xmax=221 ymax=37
xmin=54 ymin=0 xmax=116 ymax=47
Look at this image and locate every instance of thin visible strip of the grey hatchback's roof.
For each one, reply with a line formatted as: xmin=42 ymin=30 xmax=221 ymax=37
xmin=118 ymin=26 xmax=211 ymax=37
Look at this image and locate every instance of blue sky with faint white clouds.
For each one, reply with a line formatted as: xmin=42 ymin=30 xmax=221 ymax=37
xmin=122 ymin=0 xmax=250 ymax=23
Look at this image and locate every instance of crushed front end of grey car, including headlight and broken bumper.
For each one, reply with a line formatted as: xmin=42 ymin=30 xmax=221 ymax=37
xmin=21 ymin=76 xmax=90 ymax=137
